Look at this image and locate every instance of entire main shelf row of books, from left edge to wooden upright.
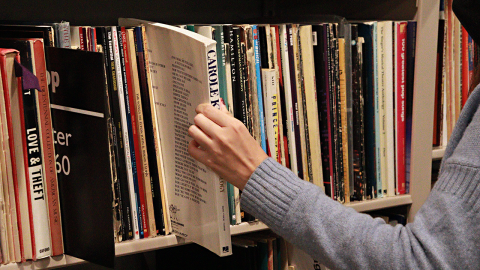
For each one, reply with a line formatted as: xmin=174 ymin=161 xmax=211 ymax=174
xmin=0 ymin=17 xmax=416 ymax=262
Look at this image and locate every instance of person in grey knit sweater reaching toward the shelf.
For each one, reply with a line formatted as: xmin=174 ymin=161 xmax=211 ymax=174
xmin=188 ymin=0 xmax=480 ymax=269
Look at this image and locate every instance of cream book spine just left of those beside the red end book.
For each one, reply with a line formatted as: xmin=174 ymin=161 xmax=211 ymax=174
xmin=382 ymin=21 xmax=396 ymax=196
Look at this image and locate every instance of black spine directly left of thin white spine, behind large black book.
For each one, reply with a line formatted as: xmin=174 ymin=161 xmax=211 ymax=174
xmin=96 ymin=27 xmax=133 ymax=241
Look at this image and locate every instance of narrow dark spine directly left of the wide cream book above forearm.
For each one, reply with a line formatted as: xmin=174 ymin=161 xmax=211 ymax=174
xmin=287 ymin=24 xmax=304 ymax=179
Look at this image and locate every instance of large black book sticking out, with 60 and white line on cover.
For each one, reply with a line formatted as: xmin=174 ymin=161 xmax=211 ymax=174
xmin=47 ymin=48 xmax=115 ymax=268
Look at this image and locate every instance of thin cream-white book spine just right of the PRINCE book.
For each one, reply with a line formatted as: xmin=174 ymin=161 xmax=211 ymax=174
xmin=279 ymin=24 xmax=298 ymax=175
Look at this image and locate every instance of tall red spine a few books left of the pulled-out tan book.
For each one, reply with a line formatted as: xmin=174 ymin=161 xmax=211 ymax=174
xmin=122 ymin=27 xmax=149 ymax=238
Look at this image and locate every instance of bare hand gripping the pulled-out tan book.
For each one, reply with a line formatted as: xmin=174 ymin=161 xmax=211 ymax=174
xmin=188 ymin=101 xmax=268 ymax=190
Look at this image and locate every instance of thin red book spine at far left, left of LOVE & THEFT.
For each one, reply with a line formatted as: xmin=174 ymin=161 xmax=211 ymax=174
xmin=0 ymin=49 xmax=26 ymax=262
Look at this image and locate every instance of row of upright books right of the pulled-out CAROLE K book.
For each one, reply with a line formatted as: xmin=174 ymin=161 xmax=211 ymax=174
xmin=175 ymin=19 xmax=416 ymax=202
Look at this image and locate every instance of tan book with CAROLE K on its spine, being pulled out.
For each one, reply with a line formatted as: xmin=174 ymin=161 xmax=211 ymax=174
xmin=119 ymin=19 xmax=232 ymax=256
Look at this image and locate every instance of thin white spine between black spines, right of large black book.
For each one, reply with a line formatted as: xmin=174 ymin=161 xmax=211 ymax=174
xmin=111 ymin=27 xmax=143 ymax=239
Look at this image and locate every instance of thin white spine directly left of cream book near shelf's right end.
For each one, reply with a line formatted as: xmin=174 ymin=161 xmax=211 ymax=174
xmin=377 ymin=22 xmax=387 ymax=198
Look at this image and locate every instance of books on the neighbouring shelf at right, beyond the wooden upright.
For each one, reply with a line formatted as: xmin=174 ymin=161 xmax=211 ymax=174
xmin=433 ymin=0 xmax=478 ymax=146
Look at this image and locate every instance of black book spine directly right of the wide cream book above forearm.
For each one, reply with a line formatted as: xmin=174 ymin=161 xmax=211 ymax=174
xmin=312 ymin=25 xmax=333 ymax=197
